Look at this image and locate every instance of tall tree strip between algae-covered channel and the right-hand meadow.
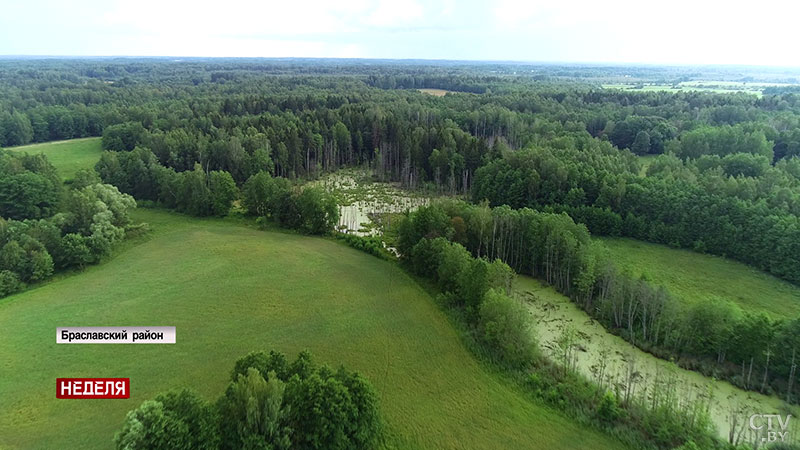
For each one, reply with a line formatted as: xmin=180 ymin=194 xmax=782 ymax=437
xmin=398 ymin=201 xmax=800 ymax=402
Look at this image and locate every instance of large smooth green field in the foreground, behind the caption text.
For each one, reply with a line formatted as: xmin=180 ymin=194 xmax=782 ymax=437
xmin=0 ymin=210 xmax=620 ymax=450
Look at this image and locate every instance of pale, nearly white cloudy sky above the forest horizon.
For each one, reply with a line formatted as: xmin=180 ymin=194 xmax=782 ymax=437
xmin=0 ymin=0 xmax=800 ymax=66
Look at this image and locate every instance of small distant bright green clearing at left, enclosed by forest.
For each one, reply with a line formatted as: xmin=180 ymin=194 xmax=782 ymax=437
xmin=6 ymin=138 xmax=103 ymax=179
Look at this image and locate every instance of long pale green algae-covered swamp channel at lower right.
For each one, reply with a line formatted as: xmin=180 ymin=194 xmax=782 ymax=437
xmin=515 ymin=276 xmax=800 ymax=442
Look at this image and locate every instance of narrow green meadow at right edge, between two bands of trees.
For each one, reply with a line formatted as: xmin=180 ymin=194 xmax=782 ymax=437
xmin=602 ymin=238 xmax=800 ymax=318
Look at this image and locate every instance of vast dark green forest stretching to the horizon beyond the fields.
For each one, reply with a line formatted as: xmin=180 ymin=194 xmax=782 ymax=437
xmin=0 ymin=59 xmax=800 ymax=283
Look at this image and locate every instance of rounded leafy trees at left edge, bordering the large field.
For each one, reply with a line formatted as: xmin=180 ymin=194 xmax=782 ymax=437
xmin=0 ymin=151 xmax=136 ymax=297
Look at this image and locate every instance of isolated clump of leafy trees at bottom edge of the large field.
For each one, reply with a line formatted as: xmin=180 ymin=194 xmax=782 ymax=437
xmin=114 ymin=351 xmax=381 ymax=450
